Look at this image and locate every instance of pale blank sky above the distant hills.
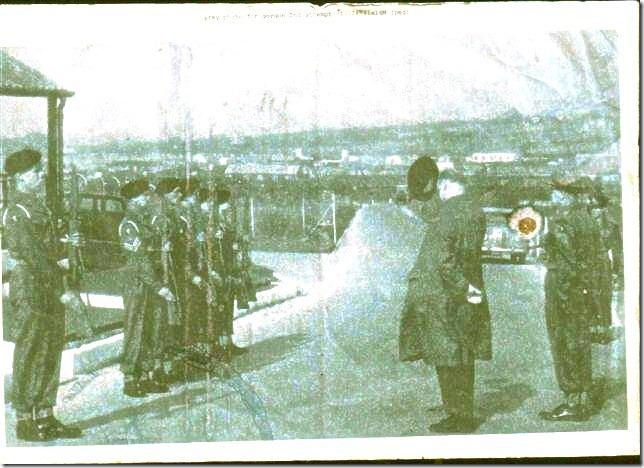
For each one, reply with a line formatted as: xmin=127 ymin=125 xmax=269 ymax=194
xmin=0 ymin=4 xmax=618 ymax=141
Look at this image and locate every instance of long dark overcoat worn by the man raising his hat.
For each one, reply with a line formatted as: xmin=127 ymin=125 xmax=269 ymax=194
xmin=400 ymin=195 xmax=492 ymax=366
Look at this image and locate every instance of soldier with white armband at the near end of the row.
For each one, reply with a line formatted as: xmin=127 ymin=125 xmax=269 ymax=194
xmin=119 ymin=179 xmax=175 ymax=397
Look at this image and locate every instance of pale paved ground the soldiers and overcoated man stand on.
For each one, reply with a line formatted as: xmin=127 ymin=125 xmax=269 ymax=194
xmin=6 ymin=206 xmax=627 ymax=445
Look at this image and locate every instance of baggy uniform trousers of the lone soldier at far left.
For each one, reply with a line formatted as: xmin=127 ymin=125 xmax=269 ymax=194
xmin=11 ymin=266 xmax=65 ymax=413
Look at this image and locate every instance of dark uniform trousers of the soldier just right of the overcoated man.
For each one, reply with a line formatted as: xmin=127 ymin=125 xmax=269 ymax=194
xmin=545 ymin=270 xmax=592 ymax=394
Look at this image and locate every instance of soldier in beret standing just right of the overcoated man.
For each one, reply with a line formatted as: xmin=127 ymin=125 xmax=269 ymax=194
xmin=539 ymin=178 xmax=600 ymax=421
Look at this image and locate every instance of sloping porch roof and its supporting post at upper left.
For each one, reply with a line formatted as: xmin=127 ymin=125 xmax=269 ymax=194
xmin=0 ymin=49 xmax=74 ymax=213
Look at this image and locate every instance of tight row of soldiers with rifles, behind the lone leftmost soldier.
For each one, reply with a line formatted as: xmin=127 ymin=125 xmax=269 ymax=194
xmin=119 ymin=178 xmax=255 ymax=397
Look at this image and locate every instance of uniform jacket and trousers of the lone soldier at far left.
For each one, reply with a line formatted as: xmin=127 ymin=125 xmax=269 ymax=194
xmin=2 ymin=193 xmax=65 ymax=412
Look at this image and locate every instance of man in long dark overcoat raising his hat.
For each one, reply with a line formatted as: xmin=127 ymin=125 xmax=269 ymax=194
xmin=400 ymin=163 xmax=492 ymax=433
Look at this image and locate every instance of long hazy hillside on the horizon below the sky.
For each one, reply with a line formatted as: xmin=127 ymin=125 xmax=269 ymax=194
xmin=0 ymin=106 xmax=619 ymax=165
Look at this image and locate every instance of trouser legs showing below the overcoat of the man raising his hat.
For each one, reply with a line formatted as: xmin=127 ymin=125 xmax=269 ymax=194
xmin=436 ymin=363 xmax=474 ymax=418
